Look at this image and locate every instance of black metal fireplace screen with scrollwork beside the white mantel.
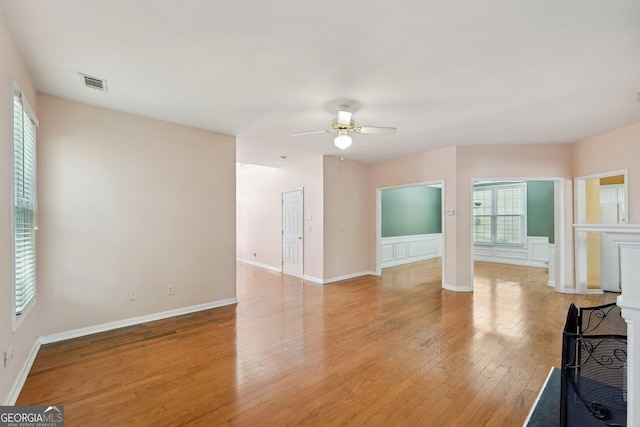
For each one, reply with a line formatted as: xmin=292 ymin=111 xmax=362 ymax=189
xmin=560 ymin=303 xmax=627 ymax=426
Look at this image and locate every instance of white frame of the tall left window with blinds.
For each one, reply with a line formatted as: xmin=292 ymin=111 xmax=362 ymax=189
xmin=10 ymin=82 xmax=39 ymax=331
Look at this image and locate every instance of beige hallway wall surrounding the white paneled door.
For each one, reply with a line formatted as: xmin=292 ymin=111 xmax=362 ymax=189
xmin=237 ymin=156 xmax=324 ymax=280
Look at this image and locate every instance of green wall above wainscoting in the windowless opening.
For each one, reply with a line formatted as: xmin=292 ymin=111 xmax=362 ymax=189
xmin=381 ymin=185 xmax=442 ymax=237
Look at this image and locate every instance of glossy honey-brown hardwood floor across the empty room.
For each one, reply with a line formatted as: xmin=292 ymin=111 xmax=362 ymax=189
xmin=17 ymin=259 xmax=616 ymax=426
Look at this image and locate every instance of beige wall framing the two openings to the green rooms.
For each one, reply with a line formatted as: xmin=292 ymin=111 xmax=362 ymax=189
xmin=368 ymin=144 xmax=573 ymax=290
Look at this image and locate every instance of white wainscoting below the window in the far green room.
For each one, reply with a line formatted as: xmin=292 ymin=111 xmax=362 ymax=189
xmin=473 ymin=236 xmax=549 ymax=267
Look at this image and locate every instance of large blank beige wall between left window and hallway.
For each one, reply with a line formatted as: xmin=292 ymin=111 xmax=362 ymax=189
xmin=38 ymin=95 xmax=236 ymax=335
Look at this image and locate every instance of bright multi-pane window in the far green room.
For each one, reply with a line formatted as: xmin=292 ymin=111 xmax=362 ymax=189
xmin=473 ymin=183 xmax=526 ymax=245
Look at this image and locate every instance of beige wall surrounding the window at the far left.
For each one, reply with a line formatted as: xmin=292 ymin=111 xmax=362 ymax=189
xmin=0 ymin=12 xmax=38 ymax=404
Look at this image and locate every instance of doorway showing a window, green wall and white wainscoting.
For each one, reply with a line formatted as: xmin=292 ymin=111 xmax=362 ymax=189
xmin=469 ymin=177 xmax=565 ymax=292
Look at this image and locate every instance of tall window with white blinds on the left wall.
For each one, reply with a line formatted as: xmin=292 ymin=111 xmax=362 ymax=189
xmin=13 ymin=89 xmax=36 ymax=315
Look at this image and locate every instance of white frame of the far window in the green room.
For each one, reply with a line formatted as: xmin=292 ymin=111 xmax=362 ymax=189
xmin=471 ymin=182 xmax=527 ymax=247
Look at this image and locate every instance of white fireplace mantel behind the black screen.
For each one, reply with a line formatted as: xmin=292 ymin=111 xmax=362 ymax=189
xmin=574 ymin=224 xmax=640 ymax=427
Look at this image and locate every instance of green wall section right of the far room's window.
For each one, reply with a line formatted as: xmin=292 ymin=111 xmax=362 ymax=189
xmin=527 ymin=181 xmax=555 ymax=243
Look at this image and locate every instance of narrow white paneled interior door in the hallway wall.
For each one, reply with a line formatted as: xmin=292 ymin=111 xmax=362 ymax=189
xmin=282 ymin=190 xmax=303 ymax=276
